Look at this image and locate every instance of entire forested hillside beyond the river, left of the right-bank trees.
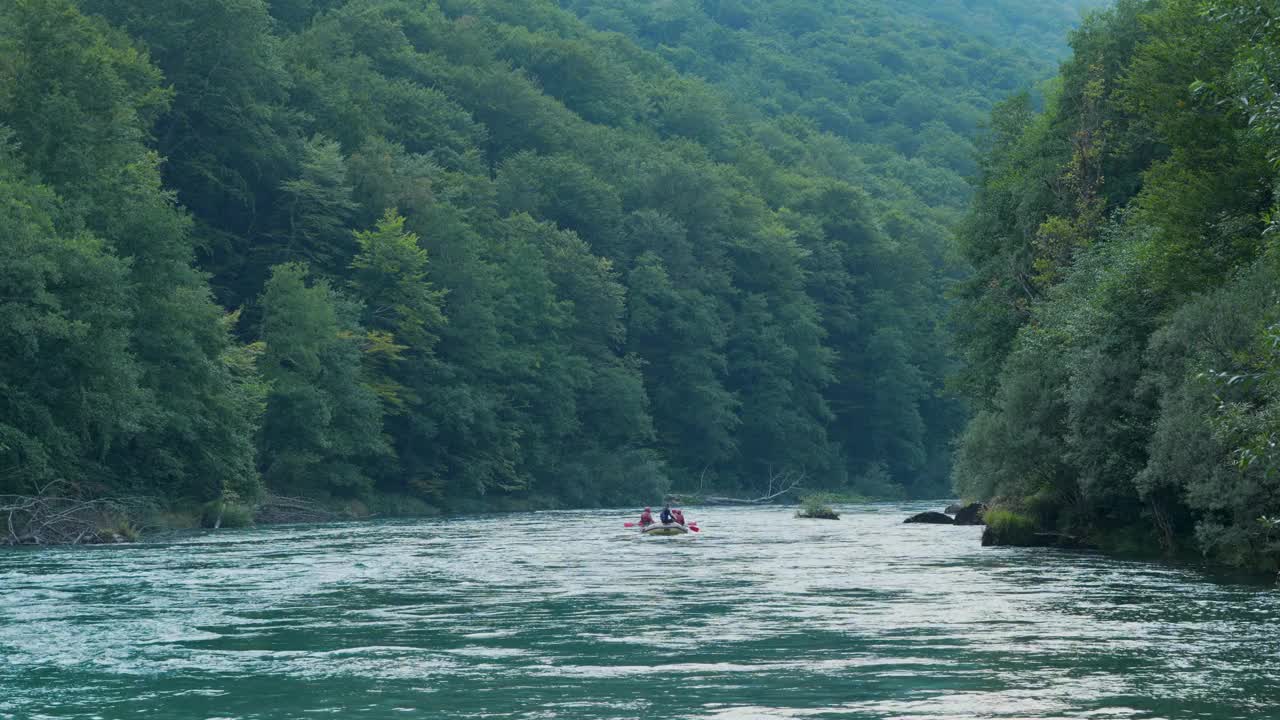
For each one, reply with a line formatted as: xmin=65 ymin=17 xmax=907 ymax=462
xmin=0 ymin=0 xmax=1090 ymax=520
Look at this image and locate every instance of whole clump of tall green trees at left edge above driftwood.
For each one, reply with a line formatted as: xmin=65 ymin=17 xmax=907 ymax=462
xmin=0 ymin=0 xmax=260 ymax=500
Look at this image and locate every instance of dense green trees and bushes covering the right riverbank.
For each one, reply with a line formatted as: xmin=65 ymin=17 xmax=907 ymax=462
xmin=955 ymin=0 xmax=1280 ymax=568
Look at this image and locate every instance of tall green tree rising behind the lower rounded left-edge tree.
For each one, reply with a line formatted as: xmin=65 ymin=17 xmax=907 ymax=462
xmin=0 ymin=0 xmax=257 ymax=498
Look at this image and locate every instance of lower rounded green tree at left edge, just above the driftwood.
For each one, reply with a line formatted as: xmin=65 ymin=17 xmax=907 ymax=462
xmin=0 ymin=147 xmax=141 ymax=492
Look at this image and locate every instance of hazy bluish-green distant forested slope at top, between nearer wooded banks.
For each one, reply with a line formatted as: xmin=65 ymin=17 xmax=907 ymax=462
xmin=559 ymin=0 xmax=1105 ymax=252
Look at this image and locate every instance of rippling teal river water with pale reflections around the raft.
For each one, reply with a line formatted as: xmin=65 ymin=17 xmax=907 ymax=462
xmin=0 ymin=505 xmax=1280 ymax=720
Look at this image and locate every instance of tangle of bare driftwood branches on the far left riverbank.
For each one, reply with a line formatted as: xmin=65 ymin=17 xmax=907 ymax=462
xmin=0 ymin=483 xmax=154 ymax=546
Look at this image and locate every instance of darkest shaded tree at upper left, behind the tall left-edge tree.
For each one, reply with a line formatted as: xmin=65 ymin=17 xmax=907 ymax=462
xmin=81 ymin=0 xmax=302 ymax=306
